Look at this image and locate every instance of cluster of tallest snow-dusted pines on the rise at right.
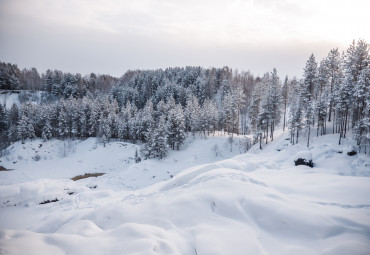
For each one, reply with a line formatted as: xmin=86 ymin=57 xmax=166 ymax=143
xmin=289 ymin=40 xmax=370 ymax=153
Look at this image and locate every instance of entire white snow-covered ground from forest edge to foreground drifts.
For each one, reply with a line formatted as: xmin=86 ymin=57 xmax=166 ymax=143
xmin=0 ymin=133 xmax=370 ymax=255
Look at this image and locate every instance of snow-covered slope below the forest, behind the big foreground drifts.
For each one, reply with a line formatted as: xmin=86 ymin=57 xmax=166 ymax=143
xmin=0 ymin=135 xmax=249 ymax=189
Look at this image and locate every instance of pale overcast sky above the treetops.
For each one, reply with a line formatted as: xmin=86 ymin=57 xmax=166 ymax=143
xmin=0 ymin=0 xmax=370 ymax=78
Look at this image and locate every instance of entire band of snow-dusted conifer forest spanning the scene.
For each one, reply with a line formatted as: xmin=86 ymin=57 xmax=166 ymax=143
xmin=0 ymin=40 xmax=370 ymax=158
